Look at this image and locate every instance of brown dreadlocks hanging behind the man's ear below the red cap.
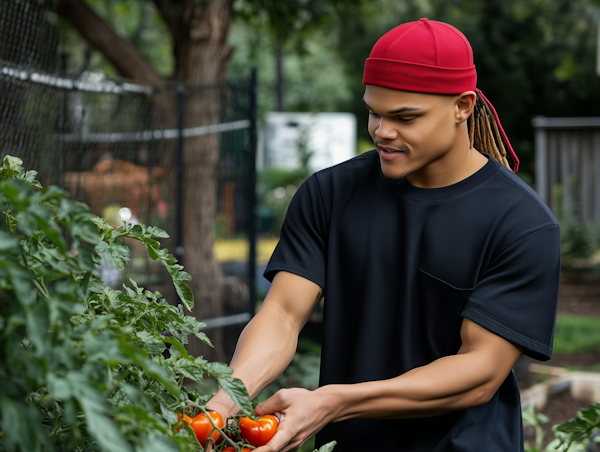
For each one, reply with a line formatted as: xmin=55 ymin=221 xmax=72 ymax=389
xmin=469 ymin=95 xmax=511 ymax=169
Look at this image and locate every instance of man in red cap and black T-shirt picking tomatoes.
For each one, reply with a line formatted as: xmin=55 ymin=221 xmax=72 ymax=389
xmin=210 ymin=19 xmax=560 ymax=452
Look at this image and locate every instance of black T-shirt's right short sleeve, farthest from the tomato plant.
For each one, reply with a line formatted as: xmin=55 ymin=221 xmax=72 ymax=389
xmin=462 ymin=223 xmax=560 ymax=361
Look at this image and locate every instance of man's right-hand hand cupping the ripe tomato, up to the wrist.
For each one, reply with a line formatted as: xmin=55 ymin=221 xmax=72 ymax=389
xmin=254 ymin=388 xmax=334 ymax=452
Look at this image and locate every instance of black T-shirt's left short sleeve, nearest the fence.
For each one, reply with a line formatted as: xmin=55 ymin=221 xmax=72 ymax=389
xmin=264 ymin=173 xmax=327 ymax=288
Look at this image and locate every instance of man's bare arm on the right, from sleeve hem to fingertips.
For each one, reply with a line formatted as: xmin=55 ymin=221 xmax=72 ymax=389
xmin=251 ymin=319 xmax=521 ymax=452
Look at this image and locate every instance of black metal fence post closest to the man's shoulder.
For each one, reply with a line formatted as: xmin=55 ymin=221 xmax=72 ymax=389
xmin=248 ymin=67 xmax=257 ymax=317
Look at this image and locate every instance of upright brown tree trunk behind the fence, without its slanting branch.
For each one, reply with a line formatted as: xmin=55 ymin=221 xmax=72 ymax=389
xmin=175 ymin=0 xmax=232 ymax=361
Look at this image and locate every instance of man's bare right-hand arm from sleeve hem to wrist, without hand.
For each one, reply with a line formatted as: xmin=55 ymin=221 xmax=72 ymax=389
xmin=315 ymin=320 xmax=521 ymax=422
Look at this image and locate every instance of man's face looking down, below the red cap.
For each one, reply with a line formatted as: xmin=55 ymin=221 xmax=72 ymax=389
xmin=363 ymin=85 xmax=460 ymax=180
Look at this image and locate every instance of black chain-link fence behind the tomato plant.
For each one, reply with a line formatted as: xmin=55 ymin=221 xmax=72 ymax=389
xmin=0 ymin=0 xmax=256 ymax=360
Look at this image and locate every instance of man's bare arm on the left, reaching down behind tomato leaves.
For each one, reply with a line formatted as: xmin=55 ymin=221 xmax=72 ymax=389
xmin=208 ymin=272 xmax=323 ymax=419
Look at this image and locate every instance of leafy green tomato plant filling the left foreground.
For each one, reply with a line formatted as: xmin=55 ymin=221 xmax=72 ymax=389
xmin=0 ymin=156 xmax=253 ymax=452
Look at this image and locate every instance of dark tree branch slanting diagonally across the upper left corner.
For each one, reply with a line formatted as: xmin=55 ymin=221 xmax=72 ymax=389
xmin=56 ymin=0 xmax=164 ymax=85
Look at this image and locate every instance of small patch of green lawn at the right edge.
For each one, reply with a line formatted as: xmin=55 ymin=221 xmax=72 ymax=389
xmin=554 ymin=314 xmax=600 ymax=355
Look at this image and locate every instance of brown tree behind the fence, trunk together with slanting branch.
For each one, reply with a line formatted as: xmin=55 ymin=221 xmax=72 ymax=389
xmin=56 ymin=0 xmax=238 ymax=361
